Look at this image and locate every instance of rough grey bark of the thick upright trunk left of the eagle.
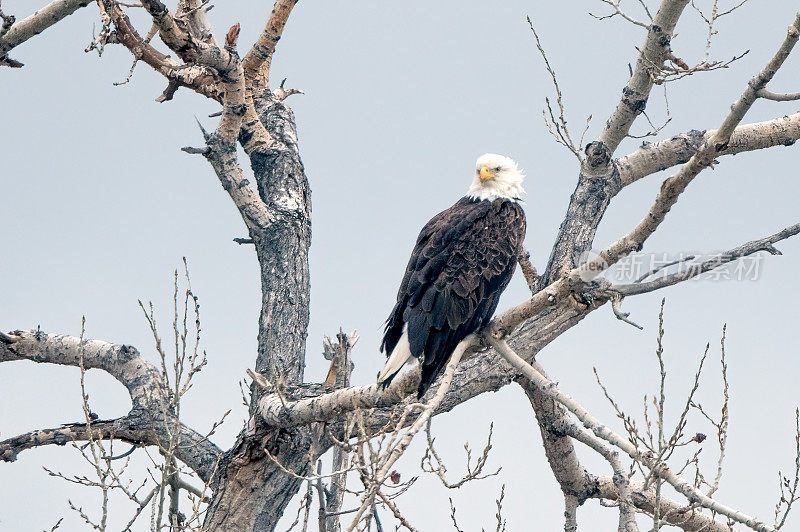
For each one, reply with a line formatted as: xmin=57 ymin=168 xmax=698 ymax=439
xmin=205 ymin=90 xmax=313 ymax=530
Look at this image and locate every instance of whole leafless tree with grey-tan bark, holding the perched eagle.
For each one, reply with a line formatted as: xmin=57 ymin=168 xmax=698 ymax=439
xmin=0 ymin=0 xmax=800 ymax=531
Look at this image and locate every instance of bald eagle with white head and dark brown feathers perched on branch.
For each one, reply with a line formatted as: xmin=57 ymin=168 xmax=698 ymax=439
xmin=378 ymin=153 xmax=525 ymax=398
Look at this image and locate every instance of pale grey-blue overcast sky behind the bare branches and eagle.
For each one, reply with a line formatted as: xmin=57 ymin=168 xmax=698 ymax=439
xmin=0 ymin=0 xmax=800 ymax=531
